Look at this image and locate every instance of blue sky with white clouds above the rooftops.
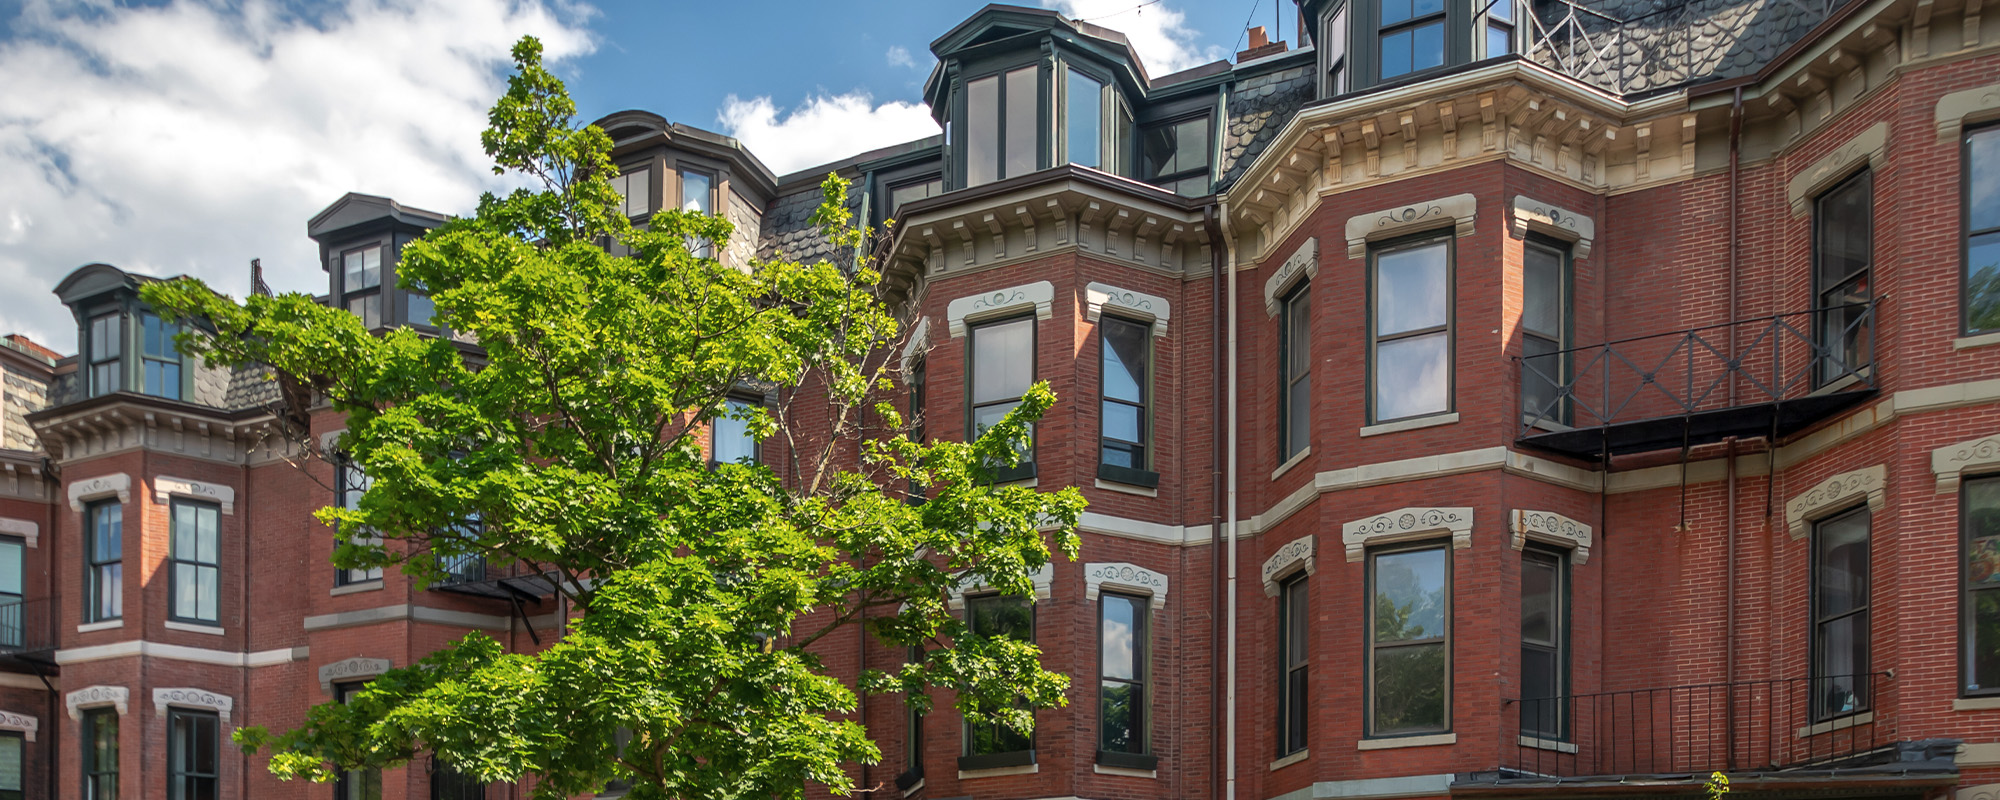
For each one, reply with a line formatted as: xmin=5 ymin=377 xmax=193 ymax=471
xmin=0 ymin=0 xmax=1296 ymax=352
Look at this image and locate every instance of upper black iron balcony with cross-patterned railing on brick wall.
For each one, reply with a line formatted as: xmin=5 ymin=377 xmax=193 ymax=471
xmin=1514 ymin=302 xmax=1874 ymax=458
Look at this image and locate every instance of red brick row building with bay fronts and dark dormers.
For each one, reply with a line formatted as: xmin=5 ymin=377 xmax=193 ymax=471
xmin=0 ymin=0 xmax=2000 ymax=800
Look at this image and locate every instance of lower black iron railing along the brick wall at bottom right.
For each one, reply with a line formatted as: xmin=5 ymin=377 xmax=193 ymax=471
xmin=1500 ymin=672 xmax=1894 ymax=778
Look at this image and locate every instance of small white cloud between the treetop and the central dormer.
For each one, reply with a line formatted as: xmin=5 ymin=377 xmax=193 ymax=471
xmin=716 ymin=92 xmax=938 ymax=174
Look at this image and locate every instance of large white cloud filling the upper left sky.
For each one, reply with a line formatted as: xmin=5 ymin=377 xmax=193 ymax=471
xmin=0 ymin=0 xmax=592 ymax=348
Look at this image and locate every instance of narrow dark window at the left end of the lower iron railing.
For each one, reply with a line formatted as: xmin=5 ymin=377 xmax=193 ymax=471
xmin=1520 ymin=548 xmax=1570 ymax=742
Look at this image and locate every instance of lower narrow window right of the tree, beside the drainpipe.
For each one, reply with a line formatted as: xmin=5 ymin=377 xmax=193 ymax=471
xmin=1098 ymin=592 xmax=1154 ymax=770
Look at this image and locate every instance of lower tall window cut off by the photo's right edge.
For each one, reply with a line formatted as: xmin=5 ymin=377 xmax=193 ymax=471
xmin=1958 ymin=476 xmax=2000 ymax=694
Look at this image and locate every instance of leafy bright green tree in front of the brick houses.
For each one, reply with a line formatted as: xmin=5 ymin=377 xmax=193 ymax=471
xmin=144 ymin=38 xmax=1084 ymax=800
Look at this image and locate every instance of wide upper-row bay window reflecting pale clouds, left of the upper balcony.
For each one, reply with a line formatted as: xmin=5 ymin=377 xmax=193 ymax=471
xmin=1368 ymin=236 xmax=1452 ymax=422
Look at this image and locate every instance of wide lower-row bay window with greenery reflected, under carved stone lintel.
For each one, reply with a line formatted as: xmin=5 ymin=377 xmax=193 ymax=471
xmin=1368 ymin=544 xmax=1452 ymax=736
